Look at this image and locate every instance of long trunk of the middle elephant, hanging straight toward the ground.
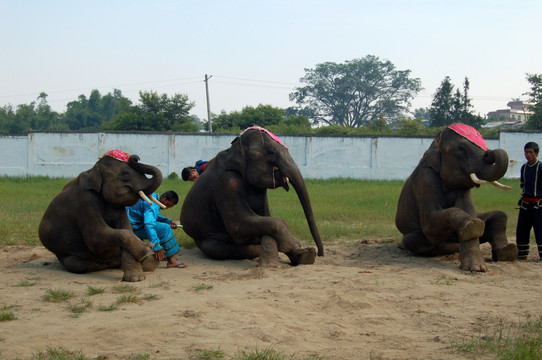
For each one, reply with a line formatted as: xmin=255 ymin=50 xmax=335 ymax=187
xmin=280 ymin=159 xmax=324 ymax=256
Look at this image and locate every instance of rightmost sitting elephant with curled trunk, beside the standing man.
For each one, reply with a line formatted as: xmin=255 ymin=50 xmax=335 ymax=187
xmin=395 ymin=124 xmax=517 ymax=271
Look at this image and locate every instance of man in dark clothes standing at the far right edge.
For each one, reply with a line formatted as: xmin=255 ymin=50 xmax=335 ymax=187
xmin=516 ymin=142 xmax=542 ymax=260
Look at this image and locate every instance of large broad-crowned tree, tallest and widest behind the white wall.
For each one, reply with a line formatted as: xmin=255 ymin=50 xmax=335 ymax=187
xmin=290 ymin=55 xmax=421 ymax=128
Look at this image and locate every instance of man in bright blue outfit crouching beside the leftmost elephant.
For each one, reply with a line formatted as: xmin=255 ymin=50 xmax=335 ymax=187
xmin=126 ymin=190 xmax=186 ymax=268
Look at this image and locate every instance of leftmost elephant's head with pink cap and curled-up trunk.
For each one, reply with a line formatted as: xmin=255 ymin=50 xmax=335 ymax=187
xmin=82 ymin=150 xmax=164 ymax=207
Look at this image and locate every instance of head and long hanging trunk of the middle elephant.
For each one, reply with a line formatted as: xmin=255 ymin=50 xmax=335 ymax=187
xmin=226 ymin=126 xmax=324 ymax=256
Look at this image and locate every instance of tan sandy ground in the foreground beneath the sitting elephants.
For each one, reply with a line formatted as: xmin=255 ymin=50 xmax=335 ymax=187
xmin=0 ymin=240 xmax=542 ymax=359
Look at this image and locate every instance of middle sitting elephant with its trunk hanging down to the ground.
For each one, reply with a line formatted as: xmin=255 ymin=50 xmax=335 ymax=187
xmin=180 ymin=126 xmax=324 ymax=266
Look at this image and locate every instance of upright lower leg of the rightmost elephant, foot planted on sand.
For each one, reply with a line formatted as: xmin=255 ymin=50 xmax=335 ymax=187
xmin=458 ymin=219 xmax=487 ymax=272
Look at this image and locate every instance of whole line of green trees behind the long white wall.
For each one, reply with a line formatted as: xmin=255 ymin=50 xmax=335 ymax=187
xmin=0 ymin=55 xmax=542 ymax=135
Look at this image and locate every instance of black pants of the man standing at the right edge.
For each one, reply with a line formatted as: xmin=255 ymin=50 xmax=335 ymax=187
xmin=516 ymin=201 xmax=542 ymax=258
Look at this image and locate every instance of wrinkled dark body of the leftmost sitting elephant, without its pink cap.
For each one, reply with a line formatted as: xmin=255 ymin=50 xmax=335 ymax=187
xmin=39 ymin=155 xmax=162 ymax=281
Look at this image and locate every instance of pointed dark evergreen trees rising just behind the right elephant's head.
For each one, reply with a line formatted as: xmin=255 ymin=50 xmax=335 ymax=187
xmin=429 ymin=76 xmax=484 ymax=128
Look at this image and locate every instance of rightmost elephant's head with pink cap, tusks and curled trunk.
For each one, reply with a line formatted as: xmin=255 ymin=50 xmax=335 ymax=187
xmin=420 ymin=124 xmax=510 ymax=190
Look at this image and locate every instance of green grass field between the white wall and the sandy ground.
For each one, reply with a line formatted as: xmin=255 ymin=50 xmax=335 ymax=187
xmin=0 ymin=177 xmax=520 ymax=248
